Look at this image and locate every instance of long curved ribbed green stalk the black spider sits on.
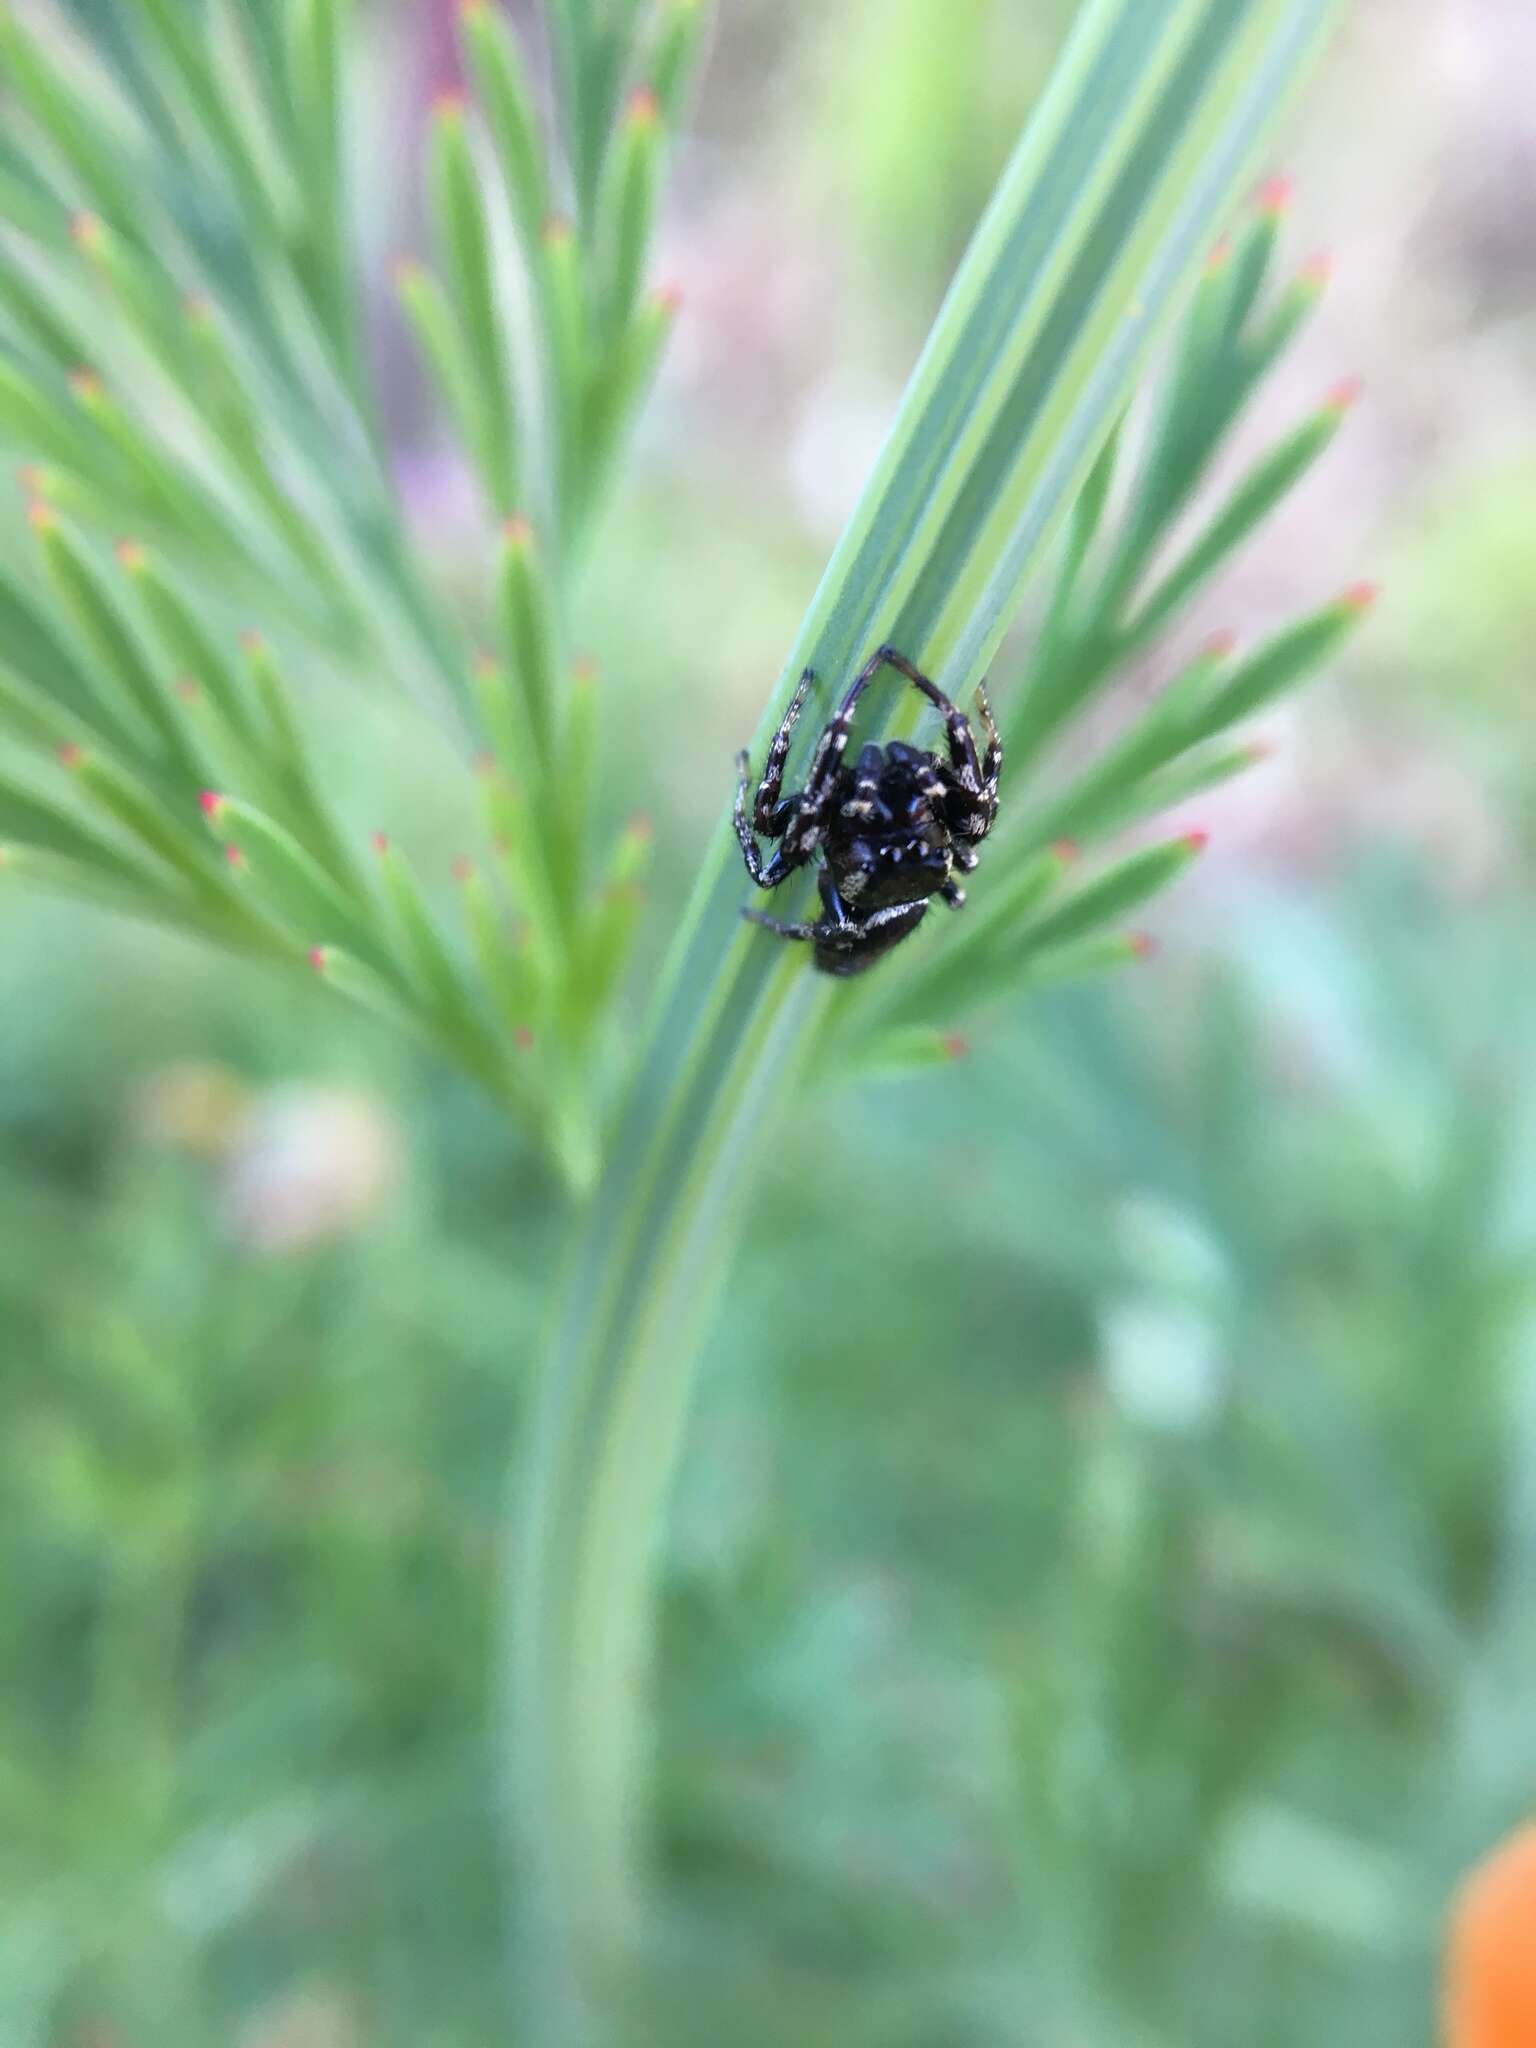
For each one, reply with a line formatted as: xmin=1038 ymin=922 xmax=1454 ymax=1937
xmin=510 ymin=0 xmax=1331 ymax=2042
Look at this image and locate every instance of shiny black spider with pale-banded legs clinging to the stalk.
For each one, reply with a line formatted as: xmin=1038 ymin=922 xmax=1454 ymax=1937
xmin=735 ymin=647 xmax=1004 ymax=975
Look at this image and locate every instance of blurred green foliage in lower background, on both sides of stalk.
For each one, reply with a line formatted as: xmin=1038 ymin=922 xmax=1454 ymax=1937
xmin=0 ymin=872 xmax=1536 ymax=2048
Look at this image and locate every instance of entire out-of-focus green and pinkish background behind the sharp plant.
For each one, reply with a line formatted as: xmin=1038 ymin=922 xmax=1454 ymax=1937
xmin=0 ymin=0 xmax=1536 ymax=2048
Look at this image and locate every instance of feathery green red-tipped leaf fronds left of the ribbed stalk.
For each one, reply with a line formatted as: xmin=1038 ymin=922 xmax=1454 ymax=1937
xmin=0 ymin=0 xmax=705 ymax=1188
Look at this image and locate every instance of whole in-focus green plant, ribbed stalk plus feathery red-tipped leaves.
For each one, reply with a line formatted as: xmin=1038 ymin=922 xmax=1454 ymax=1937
xmin=0 ymin=0 xmax=1366 ymax=2040
